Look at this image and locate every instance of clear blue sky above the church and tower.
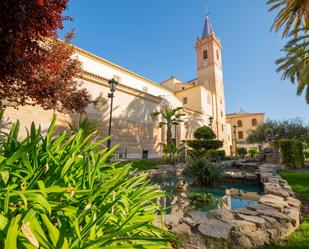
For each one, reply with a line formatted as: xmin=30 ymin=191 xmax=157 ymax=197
xmin=61 ymin=0 xmax=309 ymax=123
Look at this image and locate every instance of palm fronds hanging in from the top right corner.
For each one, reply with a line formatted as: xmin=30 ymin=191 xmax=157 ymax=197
xmin=267 ymin=0 xmax=309 ymax=101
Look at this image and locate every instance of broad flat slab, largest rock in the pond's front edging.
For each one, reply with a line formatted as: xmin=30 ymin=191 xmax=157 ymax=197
xmin=198 ymin=219 xmax=232 ymax=240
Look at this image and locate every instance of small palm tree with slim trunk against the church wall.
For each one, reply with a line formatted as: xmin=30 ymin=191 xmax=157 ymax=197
xmin=152 ymin=107 xmax=186 ymax=145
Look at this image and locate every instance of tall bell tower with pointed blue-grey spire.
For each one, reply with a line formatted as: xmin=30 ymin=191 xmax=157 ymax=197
xmin=195 ymin=13 xmax=226 ymax=140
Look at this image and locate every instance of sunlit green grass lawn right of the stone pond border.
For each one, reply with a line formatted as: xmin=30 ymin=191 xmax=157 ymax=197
xmin=260 ymin=170 xmax=309 ymax=249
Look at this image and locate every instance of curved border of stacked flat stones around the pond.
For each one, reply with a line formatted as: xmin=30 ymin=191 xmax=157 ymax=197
xmin=165 ymin=164 xmax=301 ymax=249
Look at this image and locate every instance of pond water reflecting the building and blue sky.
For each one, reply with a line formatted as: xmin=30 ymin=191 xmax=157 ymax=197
xmin=151 ymin=173 xmax=263 ymax=213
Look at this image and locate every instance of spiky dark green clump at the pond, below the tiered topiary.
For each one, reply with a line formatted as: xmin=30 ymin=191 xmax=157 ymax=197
xmin=186 ymin=157 xmax=225 ymax=184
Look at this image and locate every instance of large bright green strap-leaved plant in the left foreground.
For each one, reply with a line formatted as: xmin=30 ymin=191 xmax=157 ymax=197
xmin=0 ymin=118 xmax=174 ymax=249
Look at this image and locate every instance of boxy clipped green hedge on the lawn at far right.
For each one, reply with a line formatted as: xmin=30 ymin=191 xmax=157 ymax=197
xmin=279 ymin=139 xmax=305 ymax=168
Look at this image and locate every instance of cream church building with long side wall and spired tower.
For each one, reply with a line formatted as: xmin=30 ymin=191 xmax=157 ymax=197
xmin=5 ymin=13 xmax=232 ymax=159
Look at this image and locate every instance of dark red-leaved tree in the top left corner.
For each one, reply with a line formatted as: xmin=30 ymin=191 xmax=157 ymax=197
xmin=0 ymin=0 xmax=89 ymax=113
